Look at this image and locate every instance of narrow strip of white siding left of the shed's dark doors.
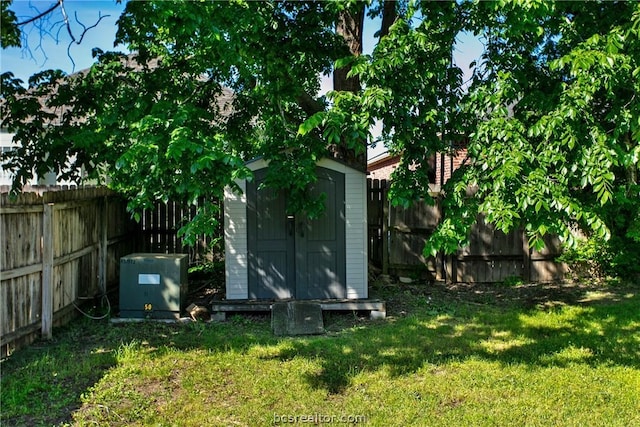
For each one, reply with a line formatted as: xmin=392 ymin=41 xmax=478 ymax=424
xmin=224 ymin=181 xmax=249 ymax=299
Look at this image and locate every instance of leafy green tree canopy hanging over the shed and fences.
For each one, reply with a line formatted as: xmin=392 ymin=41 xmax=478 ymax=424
xmin=2 ymin=0 xmax=640 ymax=253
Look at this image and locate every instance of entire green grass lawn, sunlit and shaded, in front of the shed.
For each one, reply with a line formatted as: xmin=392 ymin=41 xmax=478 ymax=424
xmin=1 ymin=284 xmax=640 ymax=427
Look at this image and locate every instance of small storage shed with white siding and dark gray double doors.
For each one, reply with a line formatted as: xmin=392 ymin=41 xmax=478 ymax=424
xmin=224 ymin=159 xmax=368 ymax=300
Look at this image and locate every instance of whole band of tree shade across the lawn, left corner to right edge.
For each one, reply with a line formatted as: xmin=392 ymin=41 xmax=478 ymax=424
xmin=1 ymin=282 xmax=640 ymax=425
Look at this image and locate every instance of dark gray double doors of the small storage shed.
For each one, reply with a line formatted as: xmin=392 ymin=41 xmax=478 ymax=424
xmin=247 ymin=168 xmax=346 ymax=299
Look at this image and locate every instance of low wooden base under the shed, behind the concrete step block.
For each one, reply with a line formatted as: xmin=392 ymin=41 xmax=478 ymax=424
xmin=211 ymin=299 xmax=387 ymax=321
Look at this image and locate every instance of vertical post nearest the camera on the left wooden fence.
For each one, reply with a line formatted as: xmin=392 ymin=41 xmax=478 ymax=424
xmin=42 ymin=203 xmax=54 ymax=339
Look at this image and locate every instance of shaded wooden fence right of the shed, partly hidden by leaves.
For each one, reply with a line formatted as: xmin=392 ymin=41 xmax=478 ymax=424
xmin=367 ymin=179 xmax=567 ymax=283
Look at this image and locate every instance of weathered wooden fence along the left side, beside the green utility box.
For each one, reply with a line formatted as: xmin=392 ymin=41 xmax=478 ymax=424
xmin=0 ymin=188 xmax=136 ymax=357
